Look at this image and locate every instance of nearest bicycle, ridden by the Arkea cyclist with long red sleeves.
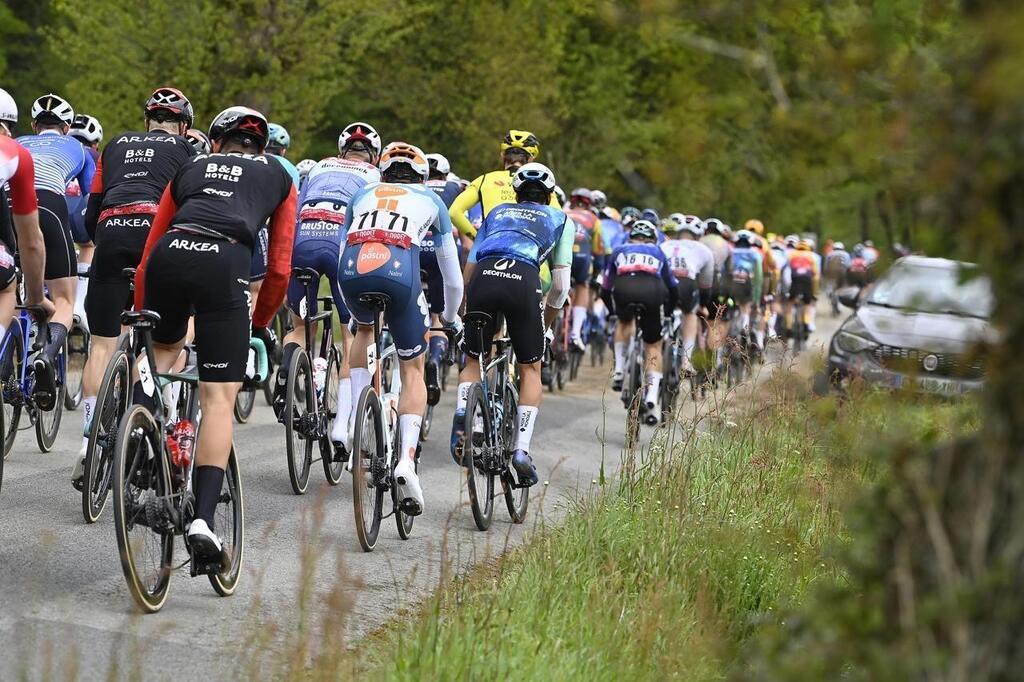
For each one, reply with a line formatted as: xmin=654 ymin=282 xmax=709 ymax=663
xmin=113 ymin=310 xmax=245 ymax=613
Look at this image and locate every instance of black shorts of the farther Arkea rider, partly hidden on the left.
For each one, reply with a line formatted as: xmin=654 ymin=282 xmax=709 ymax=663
xmin=85 ymin=213 xmax=153 ymax=338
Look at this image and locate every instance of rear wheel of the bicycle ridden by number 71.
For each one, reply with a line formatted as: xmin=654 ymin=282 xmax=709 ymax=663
xmin=351 ymin=386 xmax=387 ymax=552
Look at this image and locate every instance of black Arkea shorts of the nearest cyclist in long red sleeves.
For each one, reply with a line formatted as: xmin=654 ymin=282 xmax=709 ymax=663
xmin=145 ymin=230 xmax=252 ymax=382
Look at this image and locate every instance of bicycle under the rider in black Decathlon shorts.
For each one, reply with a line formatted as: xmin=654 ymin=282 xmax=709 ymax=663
xmin=461 ymin=311 xmax=529 ymax=530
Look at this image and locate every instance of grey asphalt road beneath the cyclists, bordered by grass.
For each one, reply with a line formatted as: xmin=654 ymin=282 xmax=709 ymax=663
xmin=0 ymin=316 xmax=835 ymax=680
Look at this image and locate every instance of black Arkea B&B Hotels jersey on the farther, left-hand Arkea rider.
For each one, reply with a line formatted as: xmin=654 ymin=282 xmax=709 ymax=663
xmin=89 ymin=130 xmax=196 ymax=209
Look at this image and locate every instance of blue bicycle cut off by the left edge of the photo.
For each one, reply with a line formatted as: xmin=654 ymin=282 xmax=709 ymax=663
xmin=0 ymin=305 xmax=68 ymax=457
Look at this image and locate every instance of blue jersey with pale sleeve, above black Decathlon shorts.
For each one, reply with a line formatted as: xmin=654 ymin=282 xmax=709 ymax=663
xmin=469 ymin=203 xmax=575 ymax=268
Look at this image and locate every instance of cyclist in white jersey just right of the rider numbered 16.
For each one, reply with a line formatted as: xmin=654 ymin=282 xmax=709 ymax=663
xmin=655 ymin=213 xmax=715 ymax=376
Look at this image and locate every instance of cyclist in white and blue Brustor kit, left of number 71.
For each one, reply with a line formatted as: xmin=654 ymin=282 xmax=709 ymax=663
xmin=274 ymin=121 xmax=381 ymax=447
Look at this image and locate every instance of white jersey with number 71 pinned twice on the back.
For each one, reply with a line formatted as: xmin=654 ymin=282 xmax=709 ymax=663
xmin=345 ymin=182 xmax=452 ymax=249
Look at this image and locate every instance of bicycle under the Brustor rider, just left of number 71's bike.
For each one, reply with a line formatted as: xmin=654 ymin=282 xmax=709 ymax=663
xmin=283 ymin=267 xmax=348 ymax=495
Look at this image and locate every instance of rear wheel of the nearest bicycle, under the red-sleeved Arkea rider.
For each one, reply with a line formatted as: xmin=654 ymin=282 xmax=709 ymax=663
xmin=114 ymin=404 xmax=174 ymax=613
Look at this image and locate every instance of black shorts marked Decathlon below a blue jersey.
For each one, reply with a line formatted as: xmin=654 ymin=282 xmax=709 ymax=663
xmin=465 ymin=258 xmax=544 ymax=365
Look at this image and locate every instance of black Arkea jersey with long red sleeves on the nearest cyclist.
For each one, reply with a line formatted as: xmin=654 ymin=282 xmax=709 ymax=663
xmin=135 ymin=153 xmax=297 ymax=327
